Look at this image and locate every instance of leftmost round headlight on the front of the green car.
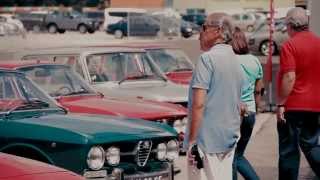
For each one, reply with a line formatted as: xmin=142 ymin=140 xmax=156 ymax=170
xmin=87 ymin=146 xmax=105 ymax=170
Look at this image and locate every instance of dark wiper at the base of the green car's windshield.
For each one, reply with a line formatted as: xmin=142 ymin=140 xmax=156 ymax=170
xmin=5 ymin=99 xmax=49 ymax=116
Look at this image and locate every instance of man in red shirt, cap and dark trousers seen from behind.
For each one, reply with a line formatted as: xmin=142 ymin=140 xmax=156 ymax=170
xmin=277 ymin=8 xmax=320 ymax=180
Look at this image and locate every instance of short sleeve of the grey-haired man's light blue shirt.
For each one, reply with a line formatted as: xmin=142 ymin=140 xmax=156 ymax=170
xmin=191 ymin=55 xmax=213 ymax=90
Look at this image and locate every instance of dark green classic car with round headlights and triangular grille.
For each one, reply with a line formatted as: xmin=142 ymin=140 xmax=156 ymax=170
xmin=0 ymin=69 xmax=179 ymax=180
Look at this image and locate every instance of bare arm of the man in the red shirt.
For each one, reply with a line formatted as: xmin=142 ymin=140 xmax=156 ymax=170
xmin=278 ymin=71 xmax=296 ymax=104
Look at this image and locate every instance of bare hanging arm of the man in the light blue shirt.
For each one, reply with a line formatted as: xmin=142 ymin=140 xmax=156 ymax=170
xmin=189 ymin=88 xmax=207 ymax=144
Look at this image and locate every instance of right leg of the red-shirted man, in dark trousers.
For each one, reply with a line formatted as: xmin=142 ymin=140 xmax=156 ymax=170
xmin=299 ymin=112 xmax=320 ymax=178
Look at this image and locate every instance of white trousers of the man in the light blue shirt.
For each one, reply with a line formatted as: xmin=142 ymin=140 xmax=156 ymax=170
xmin=204 ymin=149 xmax=235 ymax=180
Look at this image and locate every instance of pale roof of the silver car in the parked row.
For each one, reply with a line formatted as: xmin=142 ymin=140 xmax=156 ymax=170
xmin=19 ymin=46 xmax=145 ymax=56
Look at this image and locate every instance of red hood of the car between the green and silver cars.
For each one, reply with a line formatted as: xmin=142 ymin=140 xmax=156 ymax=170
xmin=58 ymin=95 xmax=187 ymax=120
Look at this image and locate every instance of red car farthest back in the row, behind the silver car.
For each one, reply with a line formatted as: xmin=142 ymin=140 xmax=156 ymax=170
xmin=93 ymin=43 xmax=194 ymax=84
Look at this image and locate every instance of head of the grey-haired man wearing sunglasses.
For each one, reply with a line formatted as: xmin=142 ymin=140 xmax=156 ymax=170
xmin=199 ymin=13 xmax=233 ymax=51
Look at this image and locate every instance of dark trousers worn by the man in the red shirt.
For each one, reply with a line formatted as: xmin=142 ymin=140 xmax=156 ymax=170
xmin=277 ymin=111 xmax=320 ymax=180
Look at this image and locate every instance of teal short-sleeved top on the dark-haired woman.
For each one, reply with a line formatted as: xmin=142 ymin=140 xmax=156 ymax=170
xmin=237 ymin=54 xmax=263 ymax=112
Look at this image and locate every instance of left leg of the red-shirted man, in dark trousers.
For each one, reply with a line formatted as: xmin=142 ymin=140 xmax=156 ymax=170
xmin=277 ymin=112 xmax=300 ymax=180
